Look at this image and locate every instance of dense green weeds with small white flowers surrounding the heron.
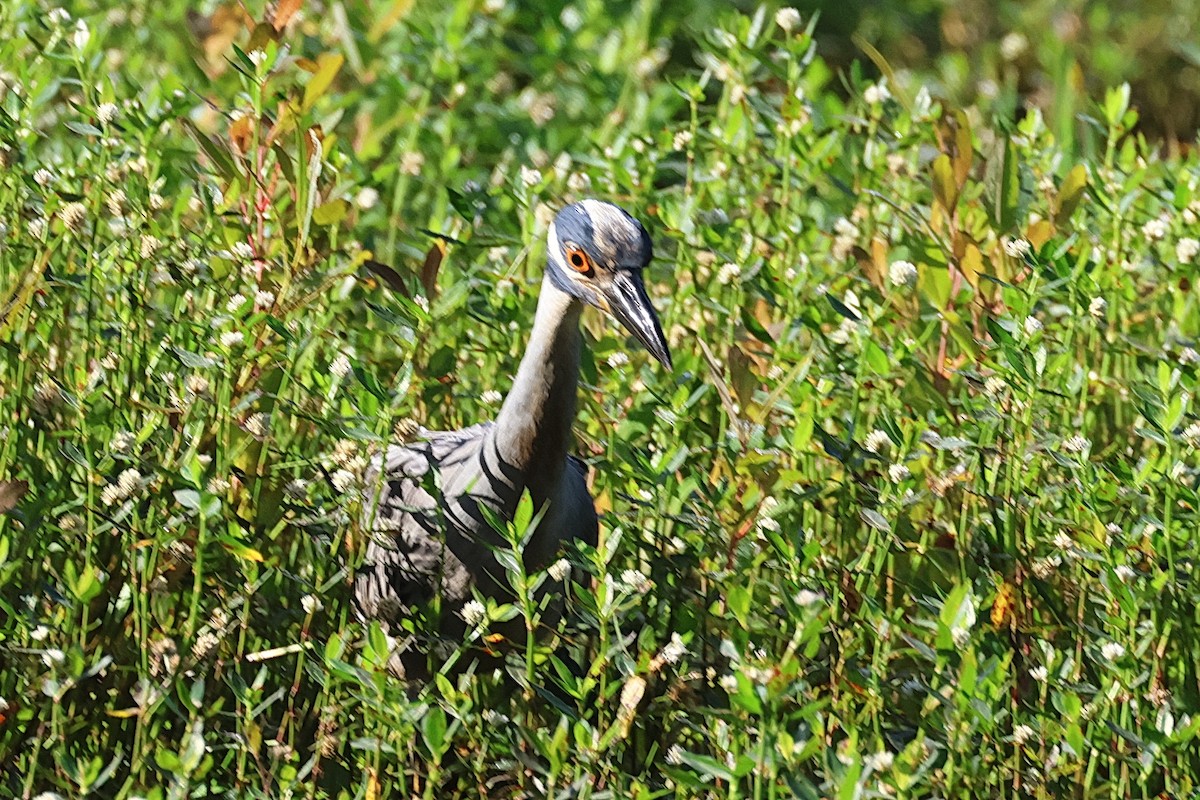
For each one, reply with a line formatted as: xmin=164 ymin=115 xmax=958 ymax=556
xmin=0 ymin=0 xmax=1200 ymax=799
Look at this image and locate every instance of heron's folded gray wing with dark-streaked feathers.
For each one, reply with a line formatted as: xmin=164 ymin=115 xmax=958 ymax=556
xmin=354 ymin=423 xmax=491 ymax=625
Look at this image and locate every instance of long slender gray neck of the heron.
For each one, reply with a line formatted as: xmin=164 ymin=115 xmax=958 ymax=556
xmin=493 ymin=275 xmax=583 ymax=504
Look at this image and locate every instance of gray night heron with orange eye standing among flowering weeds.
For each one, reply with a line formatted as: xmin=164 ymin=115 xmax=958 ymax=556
xmin=354 ymin=200 xmax=671 ymax=678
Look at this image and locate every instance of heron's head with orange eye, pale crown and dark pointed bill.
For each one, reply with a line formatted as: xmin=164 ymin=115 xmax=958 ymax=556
xmin=547 ymin=200 xmax=671 ymax=369
